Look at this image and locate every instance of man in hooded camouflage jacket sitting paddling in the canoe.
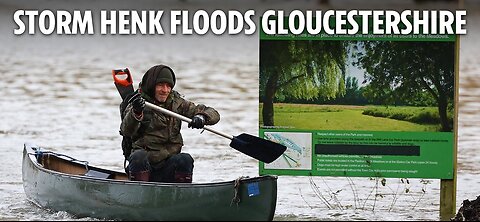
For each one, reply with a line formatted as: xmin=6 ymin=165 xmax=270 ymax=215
xmin=120 ymin=65 xmax=220 ymax=183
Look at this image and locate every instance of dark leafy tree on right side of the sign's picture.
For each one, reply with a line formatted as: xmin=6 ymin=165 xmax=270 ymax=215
xmin=358 ymin=41 xmax=455 ymax=131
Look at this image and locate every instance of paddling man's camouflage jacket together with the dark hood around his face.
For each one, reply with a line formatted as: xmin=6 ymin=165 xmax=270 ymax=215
xmin=120 ymin=65 xmax=220 ymax=164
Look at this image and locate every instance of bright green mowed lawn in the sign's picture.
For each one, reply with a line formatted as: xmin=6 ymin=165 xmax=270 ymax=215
xmin=260 ymin=103 xmax=439 ymax=132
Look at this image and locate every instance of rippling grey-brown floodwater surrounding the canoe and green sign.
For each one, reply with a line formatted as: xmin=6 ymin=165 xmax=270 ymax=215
xmin=0 ymin=0 xmax=480 ymax=220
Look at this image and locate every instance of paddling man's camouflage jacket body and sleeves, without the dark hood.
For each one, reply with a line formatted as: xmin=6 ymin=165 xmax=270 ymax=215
xmin=120 ymin=90 xmax=220 ymax=164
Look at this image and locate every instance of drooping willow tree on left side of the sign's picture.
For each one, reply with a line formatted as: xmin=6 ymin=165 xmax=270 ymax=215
xmin=260 ymin=40 xmax=347 ymax=126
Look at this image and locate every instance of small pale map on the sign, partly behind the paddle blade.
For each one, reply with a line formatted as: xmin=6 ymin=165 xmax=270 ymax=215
xmin=264 ymin=132 xmax=312 ymax=170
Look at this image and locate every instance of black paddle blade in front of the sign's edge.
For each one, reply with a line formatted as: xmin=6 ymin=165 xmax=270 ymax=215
xmin=230 ymin=133 xmax=287 ymax=163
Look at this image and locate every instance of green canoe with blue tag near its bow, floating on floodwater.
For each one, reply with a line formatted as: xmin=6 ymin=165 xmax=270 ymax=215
xmin=22 ymin=143 xmax=277 ymax=221
